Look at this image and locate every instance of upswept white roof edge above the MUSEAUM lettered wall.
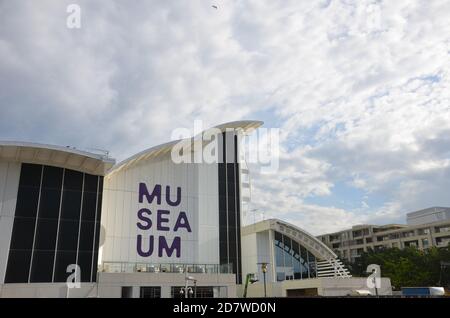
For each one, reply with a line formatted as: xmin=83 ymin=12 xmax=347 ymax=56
xmin=108 ymin=120 xmax=264 ymax=174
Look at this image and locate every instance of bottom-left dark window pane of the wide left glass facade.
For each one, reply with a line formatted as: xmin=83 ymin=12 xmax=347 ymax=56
xmin=5 ymin=250 xmax=31 ymax=283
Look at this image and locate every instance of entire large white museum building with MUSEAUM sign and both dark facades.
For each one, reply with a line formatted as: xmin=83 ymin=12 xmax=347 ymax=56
xmin=0 ymin=121 xmax=262 ymax=297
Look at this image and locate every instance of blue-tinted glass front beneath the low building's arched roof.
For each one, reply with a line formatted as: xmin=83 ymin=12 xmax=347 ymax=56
xmin=274 ymin=231 xmax=317 ymax=281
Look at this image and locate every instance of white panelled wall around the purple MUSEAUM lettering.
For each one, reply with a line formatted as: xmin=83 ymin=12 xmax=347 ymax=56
xmin=99 ymin=156 xmax=219 ymax=264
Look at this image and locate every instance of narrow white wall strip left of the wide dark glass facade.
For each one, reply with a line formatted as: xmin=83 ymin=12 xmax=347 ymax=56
xmin=0 ymin=161 xmax=21 ymax=283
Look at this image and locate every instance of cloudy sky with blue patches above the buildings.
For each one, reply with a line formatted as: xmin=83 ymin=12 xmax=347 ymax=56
xmin=0 ymin=0 xmax=450 ymax=234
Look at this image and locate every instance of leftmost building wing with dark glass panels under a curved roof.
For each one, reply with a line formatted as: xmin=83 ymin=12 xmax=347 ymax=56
xmin=0 ymin=142 xmax=114 ymax=296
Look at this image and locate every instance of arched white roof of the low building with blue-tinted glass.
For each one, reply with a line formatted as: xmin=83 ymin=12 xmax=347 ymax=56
xmin=242 ymin=219 xmax=337 ymax=260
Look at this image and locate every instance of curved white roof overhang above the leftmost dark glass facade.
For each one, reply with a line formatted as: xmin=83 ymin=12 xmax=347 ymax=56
xmin=0 ymin=141 xmax=115 ymax=175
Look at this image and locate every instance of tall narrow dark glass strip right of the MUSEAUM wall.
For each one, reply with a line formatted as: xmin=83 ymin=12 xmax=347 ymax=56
xmin=218 ymin=133 xmax=242 ymax=284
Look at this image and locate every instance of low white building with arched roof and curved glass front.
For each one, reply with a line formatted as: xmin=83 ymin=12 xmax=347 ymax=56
xmin=239 ymin=219 xmax=392 ymax=297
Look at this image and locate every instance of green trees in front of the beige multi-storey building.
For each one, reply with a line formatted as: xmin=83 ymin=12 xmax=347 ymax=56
xmin=347 ymin=246 xmax=450 ymax=290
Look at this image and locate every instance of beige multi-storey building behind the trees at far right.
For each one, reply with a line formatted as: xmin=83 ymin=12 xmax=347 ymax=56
xmin=318 ymin=208 xmax=450 ymax=262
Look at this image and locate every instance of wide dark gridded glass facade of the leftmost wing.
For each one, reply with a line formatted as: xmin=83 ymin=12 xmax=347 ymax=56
xmin=5 ymin=163 xmax=103 ymax=283
